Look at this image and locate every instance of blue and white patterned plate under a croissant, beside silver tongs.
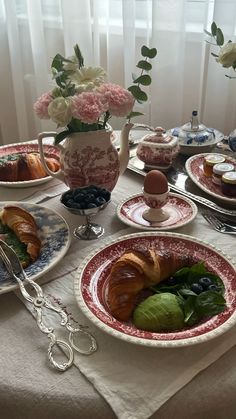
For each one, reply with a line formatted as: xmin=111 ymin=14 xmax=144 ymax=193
xmin=0 ymin=201 xmax=70 ymax=294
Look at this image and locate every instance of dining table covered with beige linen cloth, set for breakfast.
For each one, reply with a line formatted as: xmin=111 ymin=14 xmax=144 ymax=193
xmin=0 ymin=134 xmax=236 ymax=419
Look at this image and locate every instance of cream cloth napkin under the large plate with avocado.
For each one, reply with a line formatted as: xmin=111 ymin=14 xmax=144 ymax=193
xmin=16 ymin=225 xmax=236 ymax=419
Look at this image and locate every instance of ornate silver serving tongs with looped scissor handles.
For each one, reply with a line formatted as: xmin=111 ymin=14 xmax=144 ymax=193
xmin=0 ymin=240 xmax=97 ymax=371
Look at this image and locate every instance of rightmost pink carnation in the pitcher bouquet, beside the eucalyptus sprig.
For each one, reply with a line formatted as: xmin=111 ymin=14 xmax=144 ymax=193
xmin=97 ymin=83 xmax=134 ymax=116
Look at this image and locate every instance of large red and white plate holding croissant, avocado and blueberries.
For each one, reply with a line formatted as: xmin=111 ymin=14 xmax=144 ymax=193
xmin=74 ymin=232 xmax=236 ymax=347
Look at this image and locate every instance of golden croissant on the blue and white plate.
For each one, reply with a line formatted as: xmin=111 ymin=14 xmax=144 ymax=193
xmin=0 ymin=205 xmax=41 ymax=261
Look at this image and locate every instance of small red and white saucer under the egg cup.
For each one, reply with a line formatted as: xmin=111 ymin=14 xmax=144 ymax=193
xmin=117 ymin=193 xmax=197 ymax=231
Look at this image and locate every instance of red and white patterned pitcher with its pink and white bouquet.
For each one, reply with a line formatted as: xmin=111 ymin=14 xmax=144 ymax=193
xmin=34 ymin=45 xmax=157 ymax=191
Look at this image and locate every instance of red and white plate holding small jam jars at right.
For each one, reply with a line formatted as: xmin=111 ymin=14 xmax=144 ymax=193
xmin=185 ymin=153 xmax=236 ymax=205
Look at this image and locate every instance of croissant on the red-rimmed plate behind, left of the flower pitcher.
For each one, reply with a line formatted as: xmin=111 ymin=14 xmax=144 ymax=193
xmin=0 ymin=153 xmax=60 ymax=182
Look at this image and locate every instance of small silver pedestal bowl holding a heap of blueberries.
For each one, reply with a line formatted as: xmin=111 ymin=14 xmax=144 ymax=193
xmin=60 ymin=191 xmax=110 ymax=240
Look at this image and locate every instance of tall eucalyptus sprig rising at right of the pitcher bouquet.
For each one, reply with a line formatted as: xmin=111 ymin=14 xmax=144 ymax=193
xmin=127 ymin=45 xmax=157 ymax=120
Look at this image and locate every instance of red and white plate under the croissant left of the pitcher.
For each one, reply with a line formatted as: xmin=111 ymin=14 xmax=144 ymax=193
xmin=0 ymin=142 xmax=60 ymax=188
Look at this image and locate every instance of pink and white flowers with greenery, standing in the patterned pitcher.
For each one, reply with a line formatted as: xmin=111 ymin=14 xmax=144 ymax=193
xmin=34 ymin=45 xmax=157 ymax=144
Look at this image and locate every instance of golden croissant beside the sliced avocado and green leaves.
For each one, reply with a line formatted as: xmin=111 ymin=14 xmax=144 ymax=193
xmin=104 ymin=248 xmax=194 ymax=321
